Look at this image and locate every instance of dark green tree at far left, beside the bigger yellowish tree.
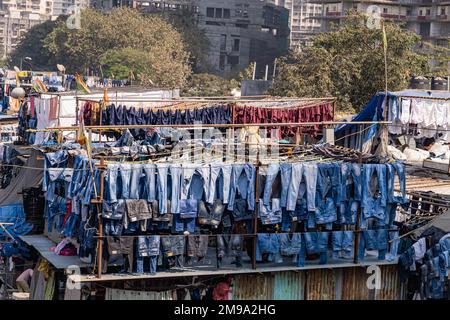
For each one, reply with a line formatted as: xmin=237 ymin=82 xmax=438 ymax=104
xmin=8 ymin=16 xmax=64 ymax=70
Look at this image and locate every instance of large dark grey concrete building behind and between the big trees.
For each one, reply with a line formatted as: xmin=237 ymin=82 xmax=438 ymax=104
xmin=93 ymin=0 xmax=289 ymax=76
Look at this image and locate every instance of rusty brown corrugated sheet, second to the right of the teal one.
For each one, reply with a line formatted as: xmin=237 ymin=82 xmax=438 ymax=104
xmin=342 ymin=267 xmax=371 ymax=300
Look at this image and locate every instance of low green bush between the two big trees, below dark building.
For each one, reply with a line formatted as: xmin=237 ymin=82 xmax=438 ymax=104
xmin=182 ymin=73 xmax=238 ymax=97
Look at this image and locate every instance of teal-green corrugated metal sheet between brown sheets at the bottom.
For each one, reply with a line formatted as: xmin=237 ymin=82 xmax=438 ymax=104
xmin=273 ymin=271 xmax=305 ymax=300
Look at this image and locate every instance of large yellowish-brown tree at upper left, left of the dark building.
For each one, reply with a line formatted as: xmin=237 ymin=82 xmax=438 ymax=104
xmin=44 ymin=8 xmax=191 ymax=87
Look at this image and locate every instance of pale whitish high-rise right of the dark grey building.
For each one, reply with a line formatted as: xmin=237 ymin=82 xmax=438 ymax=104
xmin=273 ymin=0 xmax=322 ymax=50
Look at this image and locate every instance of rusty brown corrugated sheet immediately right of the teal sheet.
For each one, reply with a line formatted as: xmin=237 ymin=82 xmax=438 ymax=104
xmin=306 ymin=269 xmax=336 ymax=300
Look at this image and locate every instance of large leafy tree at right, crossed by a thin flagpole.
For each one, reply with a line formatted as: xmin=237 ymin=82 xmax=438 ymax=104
xmin=271 ymin=12 xmax=427 ymax=112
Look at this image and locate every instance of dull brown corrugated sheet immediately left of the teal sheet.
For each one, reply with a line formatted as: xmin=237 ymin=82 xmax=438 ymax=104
xmin=233 ymin=274 xmax=274 ymax=300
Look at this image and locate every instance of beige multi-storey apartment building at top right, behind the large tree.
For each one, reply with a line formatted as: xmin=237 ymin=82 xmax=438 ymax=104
xmin=311 ymin=0 xmax=450 ymax=45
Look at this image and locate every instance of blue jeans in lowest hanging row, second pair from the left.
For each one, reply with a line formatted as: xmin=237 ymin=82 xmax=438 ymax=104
xmin=136 ymin=235 xmax=161 ymax=274
